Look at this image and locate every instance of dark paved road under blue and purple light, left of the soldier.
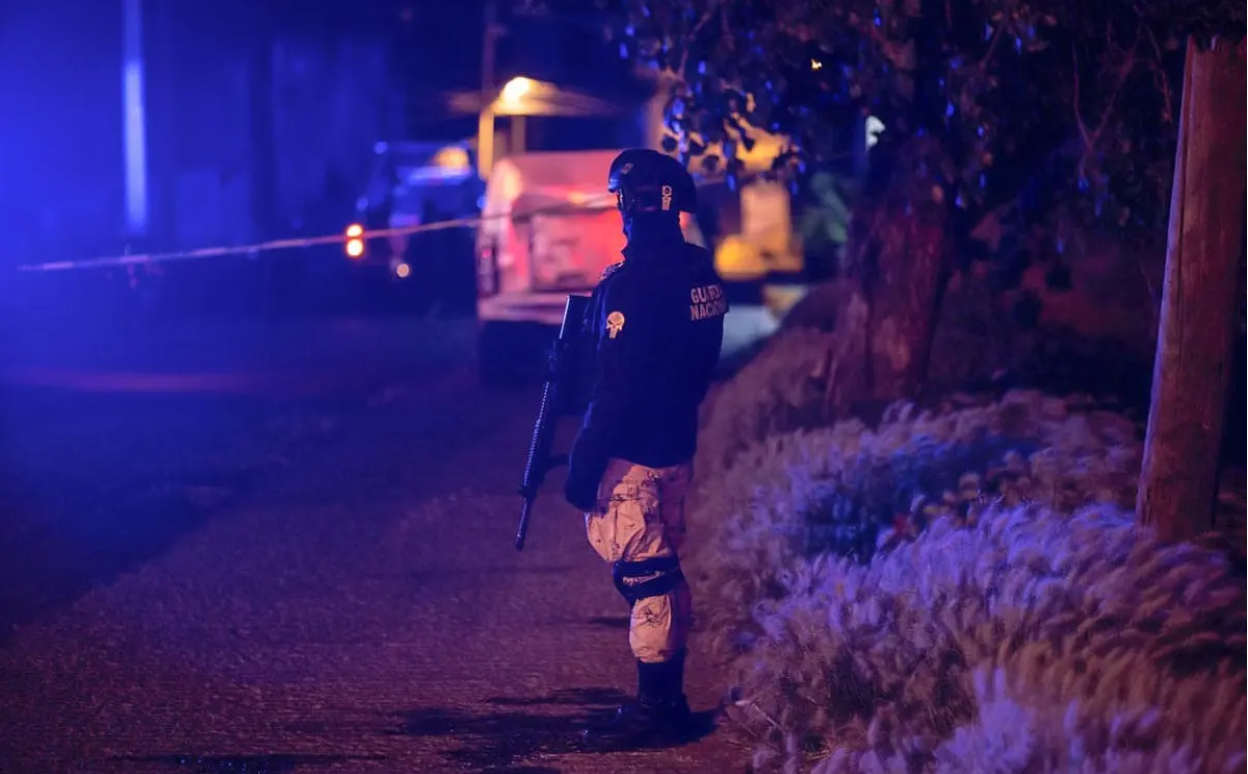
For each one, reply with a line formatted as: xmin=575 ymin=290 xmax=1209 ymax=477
xmin=0 ymin=315 xmax=740 ymax=774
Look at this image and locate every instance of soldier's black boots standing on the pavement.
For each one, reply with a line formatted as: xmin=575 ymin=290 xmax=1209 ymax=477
xmin=584 ymin=654 xmax=693 ymax=749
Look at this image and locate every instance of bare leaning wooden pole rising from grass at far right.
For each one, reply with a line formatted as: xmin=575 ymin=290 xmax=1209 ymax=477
xmin=1136 ymin=40 xmax=1246 ymax=541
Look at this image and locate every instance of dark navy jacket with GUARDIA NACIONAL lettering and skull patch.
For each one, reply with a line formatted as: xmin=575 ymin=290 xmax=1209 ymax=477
xmin=569 ymin=225 xmax=728 ymax=487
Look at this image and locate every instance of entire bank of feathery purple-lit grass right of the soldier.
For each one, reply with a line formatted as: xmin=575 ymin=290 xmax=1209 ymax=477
xmin=688 ymin=387 xmax=1246 ymax=774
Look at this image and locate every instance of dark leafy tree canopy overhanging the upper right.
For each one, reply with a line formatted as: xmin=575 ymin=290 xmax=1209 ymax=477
xmin=599 ymin=0 xmax=1244 ymax=260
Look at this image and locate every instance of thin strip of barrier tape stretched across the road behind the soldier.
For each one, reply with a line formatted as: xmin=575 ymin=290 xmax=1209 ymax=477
xmin=17 ymin=197 xmax=614 ymax=272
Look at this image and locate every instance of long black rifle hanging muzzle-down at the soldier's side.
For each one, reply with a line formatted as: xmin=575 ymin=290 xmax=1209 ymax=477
xmin=515 ymin=296 xmax=589 ymax=551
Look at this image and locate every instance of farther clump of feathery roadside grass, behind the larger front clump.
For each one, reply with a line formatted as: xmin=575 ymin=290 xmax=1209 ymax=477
xmin=688 ymin=391 xmax=1141 ymax=653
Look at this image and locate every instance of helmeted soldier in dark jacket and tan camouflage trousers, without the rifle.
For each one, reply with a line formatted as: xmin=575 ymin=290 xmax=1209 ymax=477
xmin=564 ymin=150 xmax=728 ymax=747
